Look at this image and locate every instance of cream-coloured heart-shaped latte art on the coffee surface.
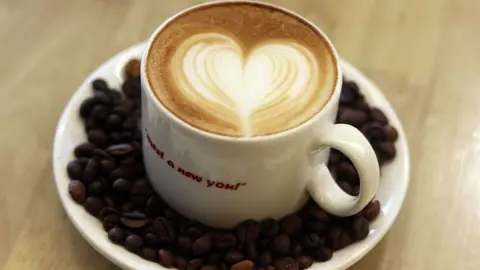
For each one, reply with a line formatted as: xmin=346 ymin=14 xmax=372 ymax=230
xmin=170 ymin=33 xmax=323 ymax=136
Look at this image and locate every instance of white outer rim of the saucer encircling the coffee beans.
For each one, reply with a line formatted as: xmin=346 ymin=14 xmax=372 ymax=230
xmin=52 ymin=42 xmax=410 ymax=270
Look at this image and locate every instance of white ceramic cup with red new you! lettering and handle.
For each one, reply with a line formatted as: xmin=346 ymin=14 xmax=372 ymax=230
xmin=141 ymin=1 xmax=379 ymax=228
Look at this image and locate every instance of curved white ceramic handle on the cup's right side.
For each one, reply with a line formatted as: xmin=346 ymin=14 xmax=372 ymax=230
xmin=307 ymin=124 xmax=380 ymax=217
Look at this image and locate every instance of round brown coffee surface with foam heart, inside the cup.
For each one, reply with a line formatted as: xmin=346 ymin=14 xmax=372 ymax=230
xmin=146 ymin=2 xmax=337 ymax=137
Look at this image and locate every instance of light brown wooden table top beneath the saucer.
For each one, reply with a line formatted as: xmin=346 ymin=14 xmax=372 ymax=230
xmin=0 ymin=0 xmax=480 ymax=270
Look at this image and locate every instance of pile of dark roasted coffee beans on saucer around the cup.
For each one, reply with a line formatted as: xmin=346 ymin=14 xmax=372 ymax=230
xmin=67 ymin=60 xmax=398 ymax=270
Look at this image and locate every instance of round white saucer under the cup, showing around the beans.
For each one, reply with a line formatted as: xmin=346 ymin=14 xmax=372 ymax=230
xmin=53 ymin=44 xmax=410 ymax=270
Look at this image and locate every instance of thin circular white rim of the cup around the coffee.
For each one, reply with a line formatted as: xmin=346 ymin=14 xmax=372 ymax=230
xmin=140 ymin=0 xmax=343 ymax=143
